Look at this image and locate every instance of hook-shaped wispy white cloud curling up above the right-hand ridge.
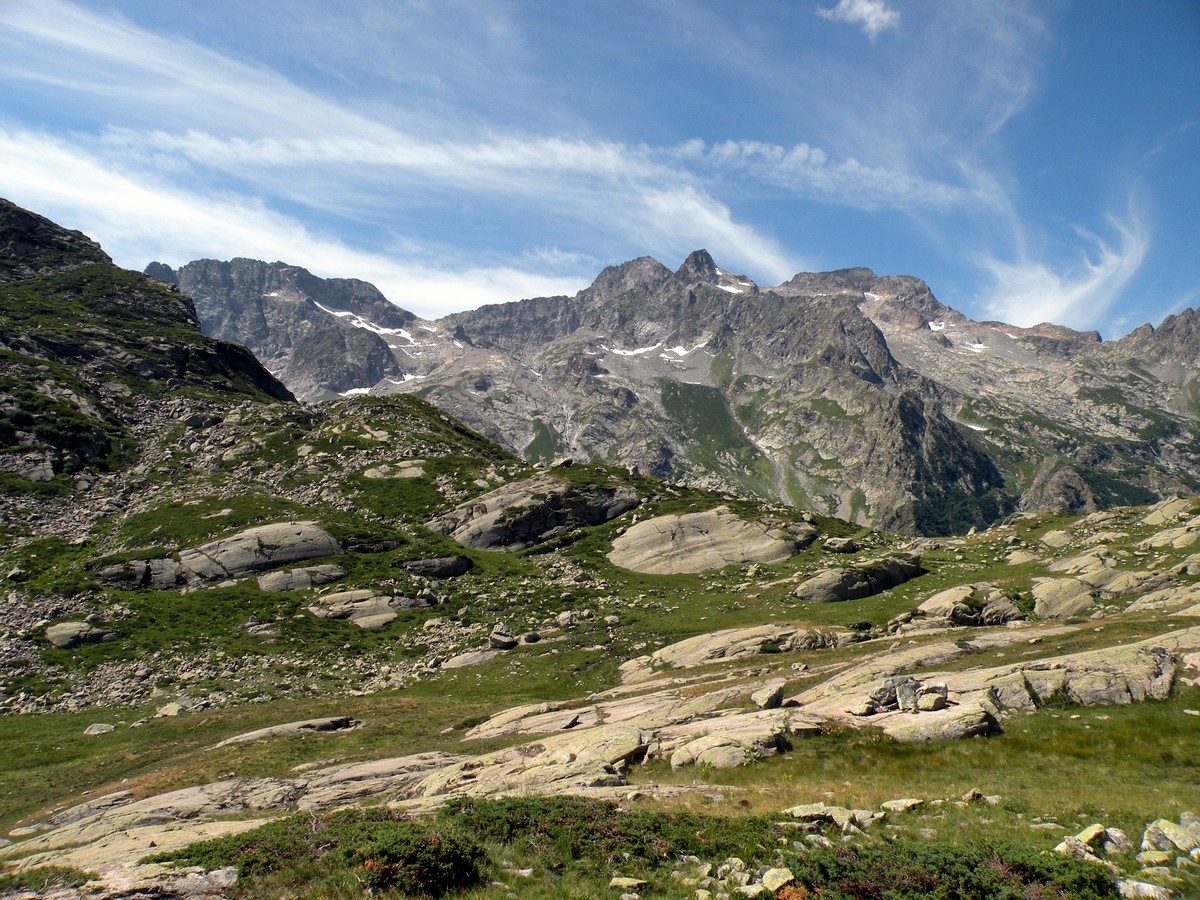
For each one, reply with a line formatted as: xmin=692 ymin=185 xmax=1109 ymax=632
xmin=982 ymin=212 xmax=1150 ymax=329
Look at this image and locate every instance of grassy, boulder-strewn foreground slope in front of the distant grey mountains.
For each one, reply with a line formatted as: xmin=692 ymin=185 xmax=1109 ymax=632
xmin=0 ymin=205 xmax=1200 ymax=900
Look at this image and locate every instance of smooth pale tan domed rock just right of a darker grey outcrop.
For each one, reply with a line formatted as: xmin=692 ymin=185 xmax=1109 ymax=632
xmin=608 ymin=506 xmax=816 ymax=575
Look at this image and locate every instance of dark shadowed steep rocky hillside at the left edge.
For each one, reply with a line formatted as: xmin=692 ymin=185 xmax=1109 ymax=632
xmin=0 ymin=200 xmax=292 ymax=482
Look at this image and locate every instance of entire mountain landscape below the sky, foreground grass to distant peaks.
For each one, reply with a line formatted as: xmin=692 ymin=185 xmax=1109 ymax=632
xmin=0 ymin=202 xmax=1200 ymax=900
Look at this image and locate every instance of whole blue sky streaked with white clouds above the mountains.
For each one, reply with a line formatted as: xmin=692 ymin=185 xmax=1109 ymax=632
xmin=0 ymin=0 xmax=1200 ymax=337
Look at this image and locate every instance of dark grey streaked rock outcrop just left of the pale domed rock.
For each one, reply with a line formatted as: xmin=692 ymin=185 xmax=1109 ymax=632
xmin=426 ymin=474 xmax=638 ymax=552
